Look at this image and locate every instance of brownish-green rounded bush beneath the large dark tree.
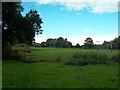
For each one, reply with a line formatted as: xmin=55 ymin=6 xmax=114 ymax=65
xmin=11 ymin=43 xmax=36 ymax=63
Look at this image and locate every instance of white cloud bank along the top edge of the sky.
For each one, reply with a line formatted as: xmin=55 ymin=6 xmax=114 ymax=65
xmin=36 ymin=0 xmax=119 ymax=13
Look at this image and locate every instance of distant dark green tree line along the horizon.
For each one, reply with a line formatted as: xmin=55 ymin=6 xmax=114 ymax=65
xmin=33 ymin=36 xmax=120 ymax=49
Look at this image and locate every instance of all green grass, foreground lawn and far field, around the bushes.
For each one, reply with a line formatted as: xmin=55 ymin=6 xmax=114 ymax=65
xmin=2 ymin=48 xmax=118 ymax=88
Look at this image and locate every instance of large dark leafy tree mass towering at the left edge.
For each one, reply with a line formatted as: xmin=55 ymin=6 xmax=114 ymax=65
xmin=2 ymin=2 xmax=43 ymax=59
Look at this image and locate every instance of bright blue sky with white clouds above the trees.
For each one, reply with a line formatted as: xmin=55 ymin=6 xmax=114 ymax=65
xmin=21 ymin=0 xmax=118 ymax=45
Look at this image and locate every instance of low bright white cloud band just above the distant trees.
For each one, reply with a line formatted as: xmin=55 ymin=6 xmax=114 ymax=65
xmin=35 ymin=34 xmax=118 ymax=45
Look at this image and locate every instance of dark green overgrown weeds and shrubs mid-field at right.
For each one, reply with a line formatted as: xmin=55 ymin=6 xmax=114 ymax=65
xmin=65 ymin=51 xmax=120 ymax=66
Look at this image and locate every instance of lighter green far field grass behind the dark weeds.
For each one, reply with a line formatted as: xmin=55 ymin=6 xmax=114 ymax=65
xmin=32 ymin=48 xmax=118 ymax=62
